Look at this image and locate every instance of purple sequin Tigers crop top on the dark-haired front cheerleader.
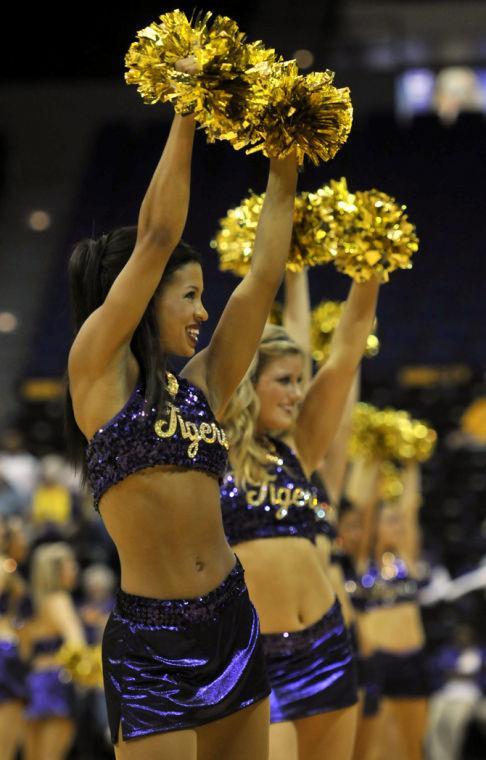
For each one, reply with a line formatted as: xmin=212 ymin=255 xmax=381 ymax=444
xmin=86 ymin=375 xmax=228 ymax=509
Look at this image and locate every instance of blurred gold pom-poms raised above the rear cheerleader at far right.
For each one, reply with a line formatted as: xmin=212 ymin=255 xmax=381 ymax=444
xmin=349 ymin=403 xmax=437 ymax=463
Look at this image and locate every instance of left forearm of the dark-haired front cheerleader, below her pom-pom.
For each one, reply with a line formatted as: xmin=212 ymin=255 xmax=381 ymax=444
xmin=138 ymin=115 xmax=195 ymax=246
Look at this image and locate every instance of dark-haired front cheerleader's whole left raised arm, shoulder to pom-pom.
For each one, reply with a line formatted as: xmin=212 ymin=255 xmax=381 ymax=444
xmin=69 ymin=116 xmax=194 ymax=380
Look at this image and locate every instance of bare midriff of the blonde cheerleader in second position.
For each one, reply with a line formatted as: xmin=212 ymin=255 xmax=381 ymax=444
xmin=233 ymin=536 xmax=334 ymax=633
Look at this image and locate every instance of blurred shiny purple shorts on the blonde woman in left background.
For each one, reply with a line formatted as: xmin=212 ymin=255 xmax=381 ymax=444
xmin=25 ymin=668 xmax=75 ymax=720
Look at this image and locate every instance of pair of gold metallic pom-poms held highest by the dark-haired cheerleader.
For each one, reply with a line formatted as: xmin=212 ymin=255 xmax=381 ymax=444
xmin=125 ymin=10 xmax=353 ymax=164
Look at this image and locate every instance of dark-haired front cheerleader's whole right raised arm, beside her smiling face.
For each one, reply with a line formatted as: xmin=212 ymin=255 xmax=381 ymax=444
xmin=185 ymin=154 xmax=297 ymax=415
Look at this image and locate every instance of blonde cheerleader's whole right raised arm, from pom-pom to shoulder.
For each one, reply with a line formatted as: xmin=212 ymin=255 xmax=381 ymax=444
xmin=295 ymin=279 xmax=379 ymax=473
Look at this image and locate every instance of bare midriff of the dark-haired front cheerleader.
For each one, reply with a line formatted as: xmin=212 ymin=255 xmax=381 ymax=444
xmin=100 ymin=466 xmax=235 ymax=599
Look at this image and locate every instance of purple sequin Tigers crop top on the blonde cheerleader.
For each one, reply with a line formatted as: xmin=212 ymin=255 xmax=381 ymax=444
xmin=221 ymin=439 xmax=327 ymax=545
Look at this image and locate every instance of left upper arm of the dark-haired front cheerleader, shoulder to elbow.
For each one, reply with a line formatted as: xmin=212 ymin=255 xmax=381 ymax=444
xmin=69 ymin=233 xmax=174 ymax=386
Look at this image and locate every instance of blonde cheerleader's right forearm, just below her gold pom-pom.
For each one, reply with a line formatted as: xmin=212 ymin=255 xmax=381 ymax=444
xmin=329 ymin=279 xmax=380 ymax=374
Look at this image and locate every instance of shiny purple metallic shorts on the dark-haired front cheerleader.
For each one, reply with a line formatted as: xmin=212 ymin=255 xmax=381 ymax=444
xmin=102 ymin=561 xmax=270 ymax=744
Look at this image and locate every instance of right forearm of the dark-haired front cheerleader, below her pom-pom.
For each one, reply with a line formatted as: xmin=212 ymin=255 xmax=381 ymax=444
xmin=251 ymin=154 xmax=297 ymax=291
